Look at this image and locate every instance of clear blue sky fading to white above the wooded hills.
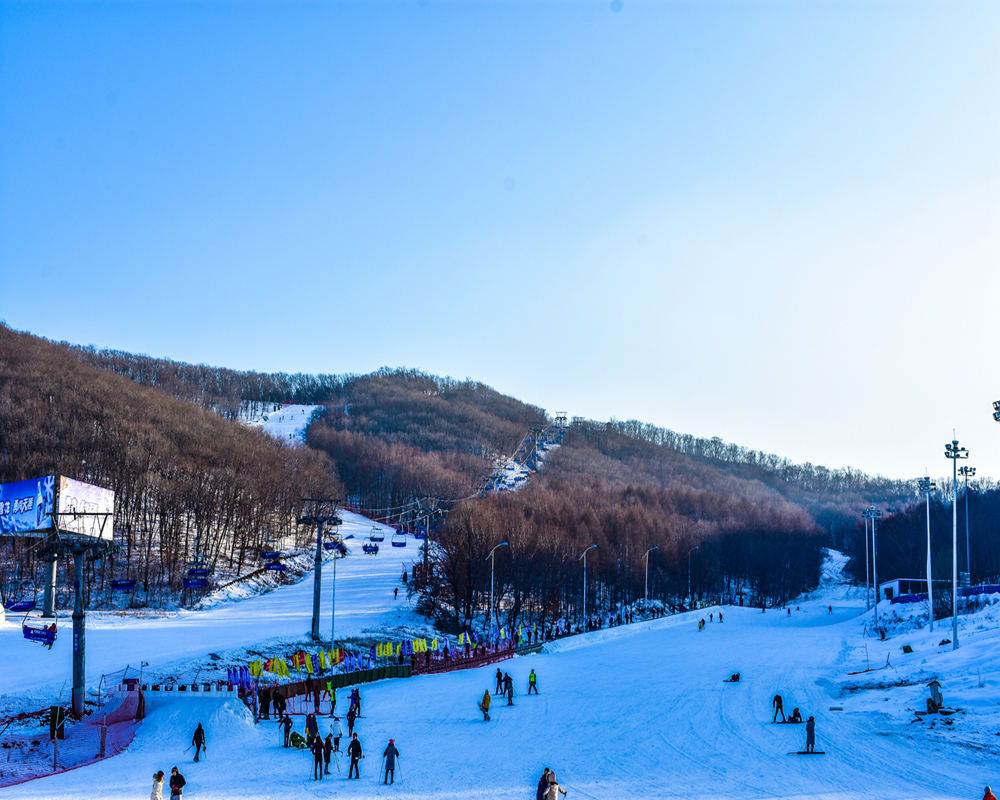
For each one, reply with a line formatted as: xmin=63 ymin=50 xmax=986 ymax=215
xmin=0 ymin=0 xmax=1000 ymax=477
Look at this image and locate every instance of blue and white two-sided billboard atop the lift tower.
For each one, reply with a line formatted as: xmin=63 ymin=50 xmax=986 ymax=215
xmin=0 ymin=475 xmax=115 ymax=541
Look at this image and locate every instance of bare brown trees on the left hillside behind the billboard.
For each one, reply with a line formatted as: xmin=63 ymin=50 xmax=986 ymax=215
xmin=0 ymin=326 xmax=343 ymax=605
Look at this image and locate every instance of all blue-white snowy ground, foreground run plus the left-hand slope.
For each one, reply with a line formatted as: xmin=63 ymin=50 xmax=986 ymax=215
xmin=0 ymin=540 xmax=1000 ymax=800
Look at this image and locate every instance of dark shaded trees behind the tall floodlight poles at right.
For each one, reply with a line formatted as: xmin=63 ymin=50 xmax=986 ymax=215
xmin=846 ymin=484 xmax=1000 ymax=584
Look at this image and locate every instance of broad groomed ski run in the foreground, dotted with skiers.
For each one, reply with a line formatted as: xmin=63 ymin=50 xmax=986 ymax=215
xmin=5 ymin=548 xmax=1000 ymax=800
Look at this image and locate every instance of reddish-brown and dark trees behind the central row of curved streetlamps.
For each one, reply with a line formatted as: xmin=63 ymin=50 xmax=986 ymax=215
xmin=428 ymin=477 xmax=826 ymax=628
